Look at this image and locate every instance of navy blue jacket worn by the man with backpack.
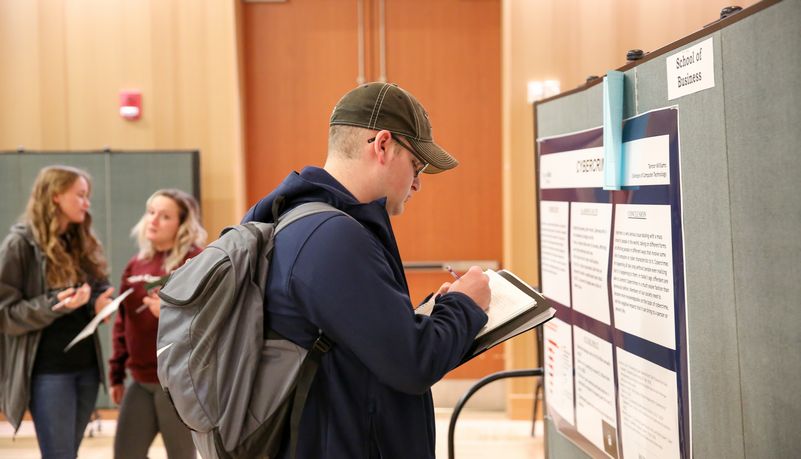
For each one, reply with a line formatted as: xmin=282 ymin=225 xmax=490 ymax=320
xmin=243 ymin=167 xmax=487 ymax=458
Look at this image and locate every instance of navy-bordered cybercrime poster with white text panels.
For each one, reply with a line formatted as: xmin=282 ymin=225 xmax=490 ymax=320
xmin=537 ymin=107 xmax=692 ymax=459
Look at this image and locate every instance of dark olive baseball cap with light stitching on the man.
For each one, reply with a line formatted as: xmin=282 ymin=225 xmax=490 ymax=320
xmin=328 ymin=83 xmax=459 ymax=174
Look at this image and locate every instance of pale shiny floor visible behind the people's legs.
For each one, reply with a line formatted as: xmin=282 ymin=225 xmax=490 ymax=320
xmin=0 ymin=409 xmax=543 ymax=459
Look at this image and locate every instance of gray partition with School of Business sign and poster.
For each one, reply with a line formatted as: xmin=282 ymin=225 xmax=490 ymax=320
xmin=534 ymin=0 xmax=801 ymax=459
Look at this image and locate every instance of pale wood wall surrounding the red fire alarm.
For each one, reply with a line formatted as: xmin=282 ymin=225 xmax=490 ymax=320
xmin=0 ymin=0 xmax=245 ymax=235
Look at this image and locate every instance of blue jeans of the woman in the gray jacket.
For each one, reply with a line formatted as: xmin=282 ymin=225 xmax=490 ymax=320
xmin=30 ymin=368 xmax=100 ymax=459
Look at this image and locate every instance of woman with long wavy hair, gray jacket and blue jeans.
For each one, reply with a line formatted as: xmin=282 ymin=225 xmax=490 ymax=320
xmin=0 ymin=166 xmax=113 ymax=458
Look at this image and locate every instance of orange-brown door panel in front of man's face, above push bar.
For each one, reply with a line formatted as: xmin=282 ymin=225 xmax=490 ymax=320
xmin=386 ymin=0 xmax=501 ymax=261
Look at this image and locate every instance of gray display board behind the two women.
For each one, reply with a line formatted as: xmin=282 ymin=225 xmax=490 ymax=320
xmin=0 ymin=151 xmax=200 ymax=407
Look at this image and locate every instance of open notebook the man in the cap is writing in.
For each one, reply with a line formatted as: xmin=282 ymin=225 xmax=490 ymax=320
xmin=415 ymin=269 xmax=556 ymax=360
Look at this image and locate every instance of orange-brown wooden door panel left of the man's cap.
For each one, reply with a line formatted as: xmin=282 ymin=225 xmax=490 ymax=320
xmin=243 ymin=0 xmax=358 ymax=205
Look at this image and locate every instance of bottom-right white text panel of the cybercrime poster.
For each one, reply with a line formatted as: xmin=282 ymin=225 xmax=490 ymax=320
xmin=617 ymin=348 xmax=680 ymax=459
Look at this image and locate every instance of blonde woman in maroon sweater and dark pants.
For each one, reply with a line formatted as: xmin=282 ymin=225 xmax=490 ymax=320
xmin=109 ymin=189 xmax=206 ymax=459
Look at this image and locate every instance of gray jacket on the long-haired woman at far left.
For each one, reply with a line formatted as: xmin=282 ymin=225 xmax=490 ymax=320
xmin=0 ymin=225 xmax=104 ymax=432
